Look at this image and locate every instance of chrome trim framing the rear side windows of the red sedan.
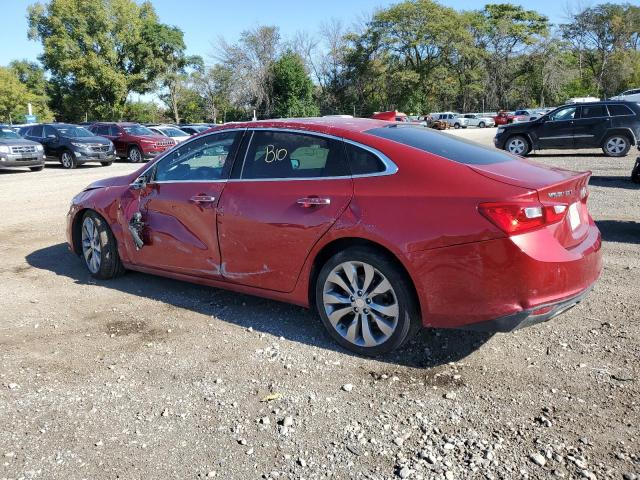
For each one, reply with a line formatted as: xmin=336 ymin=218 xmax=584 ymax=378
xmin=228 ymin=127 xmax=398 ymax=182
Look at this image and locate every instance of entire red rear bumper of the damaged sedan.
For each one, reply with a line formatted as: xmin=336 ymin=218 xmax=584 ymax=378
xmin=409 ymin=219 xmax=602 ymax=331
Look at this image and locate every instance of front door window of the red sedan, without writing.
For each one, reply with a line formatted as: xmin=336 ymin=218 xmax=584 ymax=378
xmin=155 ymin=131 xmax=241 ymax=182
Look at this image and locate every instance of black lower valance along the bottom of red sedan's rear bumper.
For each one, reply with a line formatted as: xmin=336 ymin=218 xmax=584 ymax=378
xmin=462 ymin=287 xmax=593 ymax=332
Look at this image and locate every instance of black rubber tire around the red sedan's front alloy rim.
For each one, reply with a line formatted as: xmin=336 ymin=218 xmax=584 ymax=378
xmin=79 ymin=210 xmax=125 ymax=280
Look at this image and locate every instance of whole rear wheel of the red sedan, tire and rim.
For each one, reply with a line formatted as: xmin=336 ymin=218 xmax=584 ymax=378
xmin=315 ymin=247 xmax=421 ymax=355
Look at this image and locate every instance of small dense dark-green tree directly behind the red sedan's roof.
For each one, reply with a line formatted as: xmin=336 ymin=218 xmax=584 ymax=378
xmin=271 ymin=50 xmax=320 ymax=117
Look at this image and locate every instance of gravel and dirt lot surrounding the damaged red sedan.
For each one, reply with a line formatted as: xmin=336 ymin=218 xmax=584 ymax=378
xmin=0 ymin=129 xmax=640 ymax=480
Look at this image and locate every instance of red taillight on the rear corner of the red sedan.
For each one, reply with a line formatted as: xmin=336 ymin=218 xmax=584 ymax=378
xmin=478 ymin=202 xmax=567 ymax=235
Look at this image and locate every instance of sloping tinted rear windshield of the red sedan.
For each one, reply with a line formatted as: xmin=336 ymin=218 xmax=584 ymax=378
xmin=365 ymin=125 xmax=514 ymax=165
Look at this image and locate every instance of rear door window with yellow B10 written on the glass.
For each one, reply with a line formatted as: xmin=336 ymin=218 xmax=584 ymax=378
xmin=241 ymin=131 xmax=349 ymax=179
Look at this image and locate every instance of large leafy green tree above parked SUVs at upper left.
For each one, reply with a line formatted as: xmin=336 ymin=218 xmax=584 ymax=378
xmin=28 ymin=0 xmax=185 ymax=120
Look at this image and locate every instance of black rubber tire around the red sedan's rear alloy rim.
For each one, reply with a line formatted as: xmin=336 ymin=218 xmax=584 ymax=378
xmin=315 ymin=247 xmax=422 ymax=356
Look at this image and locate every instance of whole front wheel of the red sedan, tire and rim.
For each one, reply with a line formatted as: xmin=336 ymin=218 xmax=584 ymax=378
xmin=80 ymin=210 xmax=124 ymax=279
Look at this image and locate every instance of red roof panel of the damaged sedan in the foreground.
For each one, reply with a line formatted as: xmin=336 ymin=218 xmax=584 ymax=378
xmin=212 ymin=117 xmax=396 ymax=136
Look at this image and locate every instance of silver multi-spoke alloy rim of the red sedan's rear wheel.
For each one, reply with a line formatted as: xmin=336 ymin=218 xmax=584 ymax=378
xmin=323 ymin=261 xmax=400 ymax=347
